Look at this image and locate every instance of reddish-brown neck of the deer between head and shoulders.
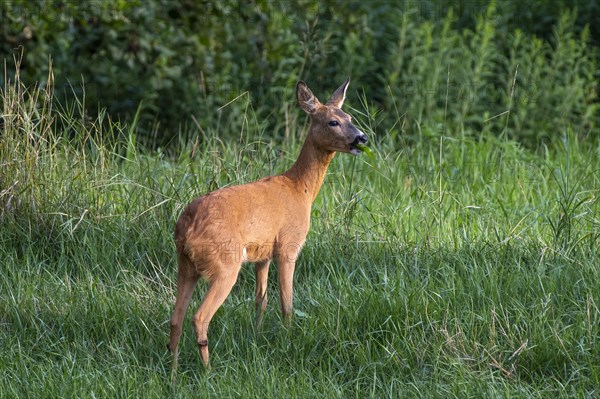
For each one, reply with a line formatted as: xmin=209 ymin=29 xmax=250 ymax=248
xmin=285 ymin=134 xmax=335 ymax=203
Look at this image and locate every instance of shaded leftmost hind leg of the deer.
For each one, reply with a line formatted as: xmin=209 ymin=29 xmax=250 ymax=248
xmin=167 ymin=255 xmax=199 ymax=372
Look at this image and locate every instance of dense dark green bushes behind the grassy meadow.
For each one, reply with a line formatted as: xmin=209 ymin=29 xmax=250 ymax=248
xmin=0 ymin=0 xmax=599 ymax=146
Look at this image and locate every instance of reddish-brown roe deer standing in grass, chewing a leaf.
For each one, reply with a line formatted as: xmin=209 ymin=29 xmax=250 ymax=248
xmin=168 ymin=79 xmax=367 ymax=371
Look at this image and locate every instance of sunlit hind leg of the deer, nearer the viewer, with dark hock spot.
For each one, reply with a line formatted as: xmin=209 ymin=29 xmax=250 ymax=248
xmin=194 ymin=265 xmax=241 ymax=369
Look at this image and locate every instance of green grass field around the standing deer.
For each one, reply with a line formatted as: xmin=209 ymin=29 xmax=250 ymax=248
xmin=0 ymin=71 xmax=600 ymax=398
